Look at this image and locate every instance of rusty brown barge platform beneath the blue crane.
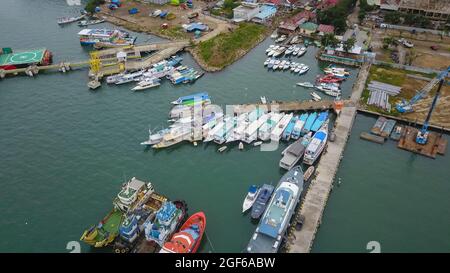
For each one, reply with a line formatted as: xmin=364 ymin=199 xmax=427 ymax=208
xmin=397 ymin=126 xmax=447 ymax=158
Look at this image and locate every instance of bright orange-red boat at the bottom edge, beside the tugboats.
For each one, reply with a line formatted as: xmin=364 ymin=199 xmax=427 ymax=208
xmin=160 ymin=212 xmax=206 ymax=253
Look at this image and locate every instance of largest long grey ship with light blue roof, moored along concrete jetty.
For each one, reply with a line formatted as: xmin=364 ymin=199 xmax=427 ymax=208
xmin=246 ymin=166 xmax=303 ymax=253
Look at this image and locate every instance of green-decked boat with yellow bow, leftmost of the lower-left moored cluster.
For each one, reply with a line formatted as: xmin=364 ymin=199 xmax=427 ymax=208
xmin=80 ymin=209 xmax=124 ymax=247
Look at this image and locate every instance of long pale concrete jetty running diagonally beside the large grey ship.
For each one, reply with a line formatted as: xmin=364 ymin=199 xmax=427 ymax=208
xmin=286 ymin=64 xmax=370 ymax=253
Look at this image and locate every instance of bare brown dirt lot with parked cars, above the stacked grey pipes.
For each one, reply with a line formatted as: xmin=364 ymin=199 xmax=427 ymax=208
xmin=372 ymin=29 xmax=450 ymax=70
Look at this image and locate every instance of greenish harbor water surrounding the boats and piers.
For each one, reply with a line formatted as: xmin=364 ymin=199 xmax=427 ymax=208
xmin=0 ymin=0 xmax=450 ymax=252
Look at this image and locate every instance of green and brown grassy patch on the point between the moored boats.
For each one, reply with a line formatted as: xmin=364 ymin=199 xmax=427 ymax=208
xmin=197 ymin=23 xmax=266 ymax=68
